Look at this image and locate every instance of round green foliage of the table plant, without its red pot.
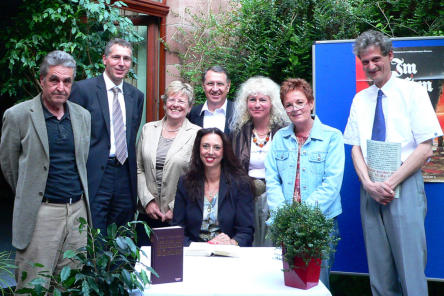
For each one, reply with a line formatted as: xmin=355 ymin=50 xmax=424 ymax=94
xmin=269 ymin=203 xmax=339 ymax=268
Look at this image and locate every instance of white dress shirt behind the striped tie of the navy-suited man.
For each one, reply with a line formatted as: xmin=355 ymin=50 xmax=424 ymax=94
xmin=103 ymin=72 xmax=126 ymax=157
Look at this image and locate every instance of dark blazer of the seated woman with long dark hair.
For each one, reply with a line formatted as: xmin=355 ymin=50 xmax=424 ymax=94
xmin=172 ymin=175 xmax=254 ymax=247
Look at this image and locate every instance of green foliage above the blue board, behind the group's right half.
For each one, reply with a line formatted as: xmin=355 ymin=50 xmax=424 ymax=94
xmin=175 ymin=0 xmax=444 ymax=102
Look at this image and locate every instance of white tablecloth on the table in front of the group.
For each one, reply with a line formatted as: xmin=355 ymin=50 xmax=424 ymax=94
xmin=137 ymin=247 xmax=331 ymax=296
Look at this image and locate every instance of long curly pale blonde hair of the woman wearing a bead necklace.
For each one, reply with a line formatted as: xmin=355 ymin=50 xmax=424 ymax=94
xmin=230 ymin=76 xmax=290 ymax=131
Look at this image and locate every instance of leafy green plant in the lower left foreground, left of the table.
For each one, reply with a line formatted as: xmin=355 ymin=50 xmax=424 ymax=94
xmin=17 ymin=218 xmax=157 ymax=296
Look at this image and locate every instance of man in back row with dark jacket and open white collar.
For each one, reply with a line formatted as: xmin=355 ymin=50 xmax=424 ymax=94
xmin=188 ymin=66 xmax=233 ymax=134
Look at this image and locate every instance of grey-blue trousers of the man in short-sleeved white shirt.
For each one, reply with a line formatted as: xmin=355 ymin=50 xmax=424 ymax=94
xmin=361 ymin=170 xmax=428 ymax=296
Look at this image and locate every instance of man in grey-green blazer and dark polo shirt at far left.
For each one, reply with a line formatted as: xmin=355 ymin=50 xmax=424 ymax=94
xmin=0 ymin=51 xmax=91 ymax=289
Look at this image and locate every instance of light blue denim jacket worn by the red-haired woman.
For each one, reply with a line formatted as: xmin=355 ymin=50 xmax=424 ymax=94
xmin=265 ymin=116 xmax=345 ymax=223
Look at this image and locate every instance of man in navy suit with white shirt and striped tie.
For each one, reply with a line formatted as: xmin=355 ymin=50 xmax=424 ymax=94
xmin=70 ymin=39 xmax=143 ymax=233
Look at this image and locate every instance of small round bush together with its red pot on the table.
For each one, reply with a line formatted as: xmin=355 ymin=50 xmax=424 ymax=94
xmin=269 ymin=203 xmax=339 ymax=289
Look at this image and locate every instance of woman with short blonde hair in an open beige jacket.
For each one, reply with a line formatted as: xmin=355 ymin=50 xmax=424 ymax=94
xmin=137 ymin=81 xmax=200 ymax=245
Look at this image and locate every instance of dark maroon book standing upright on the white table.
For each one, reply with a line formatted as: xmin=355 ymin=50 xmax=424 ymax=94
xmin=151 ymin=226 xmax=184 ymax=284
